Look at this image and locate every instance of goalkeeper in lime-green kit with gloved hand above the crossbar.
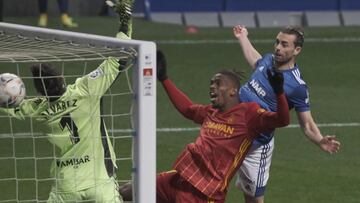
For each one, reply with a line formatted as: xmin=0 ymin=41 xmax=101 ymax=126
xmin=0 ymin=0 xmax=132 ymax=203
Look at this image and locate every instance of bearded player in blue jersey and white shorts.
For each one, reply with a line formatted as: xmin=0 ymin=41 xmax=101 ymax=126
xmin=233 ymin=25 xmax=340 ymax=203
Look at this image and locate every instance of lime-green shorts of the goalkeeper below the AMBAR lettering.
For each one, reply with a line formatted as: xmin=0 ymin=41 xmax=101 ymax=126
xmin=47 ymin=177 xmax=123 ymax=203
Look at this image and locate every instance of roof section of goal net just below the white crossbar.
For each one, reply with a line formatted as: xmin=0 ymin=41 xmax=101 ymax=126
xmin=0 ymin=32 xmax=134 ymax=63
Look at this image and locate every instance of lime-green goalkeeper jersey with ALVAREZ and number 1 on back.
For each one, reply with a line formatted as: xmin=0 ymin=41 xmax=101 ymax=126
xmin=2 ymin=58 xmax=119 ymax=192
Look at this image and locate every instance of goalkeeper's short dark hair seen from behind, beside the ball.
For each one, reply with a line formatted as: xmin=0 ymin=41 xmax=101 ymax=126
xmin=31 ymin=63 xmax=65 ymax=101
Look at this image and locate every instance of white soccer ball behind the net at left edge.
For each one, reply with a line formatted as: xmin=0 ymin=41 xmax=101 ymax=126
xmin=0 ymin=73 xmax=26 ymax=108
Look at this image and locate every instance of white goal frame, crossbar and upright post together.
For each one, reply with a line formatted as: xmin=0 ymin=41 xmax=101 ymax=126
xmin=0 ymin=23 xmax=156 ymax=203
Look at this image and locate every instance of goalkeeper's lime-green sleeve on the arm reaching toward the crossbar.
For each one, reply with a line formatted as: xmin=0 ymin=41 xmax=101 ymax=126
xmin=75 ymin=57 xmax=120 ymax=97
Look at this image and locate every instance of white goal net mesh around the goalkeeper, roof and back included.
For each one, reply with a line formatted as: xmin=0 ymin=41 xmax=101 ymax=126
xmin=0 ymin=31 xmax=137 ymax=202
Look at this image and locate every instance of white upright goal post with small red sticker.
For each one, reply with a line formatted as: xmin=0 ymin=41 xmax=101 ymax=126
xmin=134 ymin=30 xmax=156 ymax=203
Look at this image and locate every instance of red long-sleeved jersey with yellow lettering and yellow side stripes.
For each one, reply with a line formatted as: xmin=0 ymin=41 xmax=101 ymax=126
xmin=163 ymin=80 xmax=289 ymax=199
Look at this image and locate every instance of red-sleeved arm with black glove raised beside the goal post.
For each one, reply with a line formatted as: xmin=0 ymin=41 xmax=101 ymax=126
xmin=156 ymin=51 xmax=193 ymax=119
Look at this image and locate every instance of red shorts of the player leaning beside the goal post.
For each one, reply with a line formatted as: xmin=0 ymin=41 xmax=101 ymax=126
xmin=156 ymin=170 xmax=225 ymax=203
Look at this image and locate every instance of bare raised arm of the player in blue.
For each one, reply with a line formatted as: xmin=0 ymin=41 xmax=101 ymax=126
xmin=233 ymin=25 xmax=262 ymax=69
